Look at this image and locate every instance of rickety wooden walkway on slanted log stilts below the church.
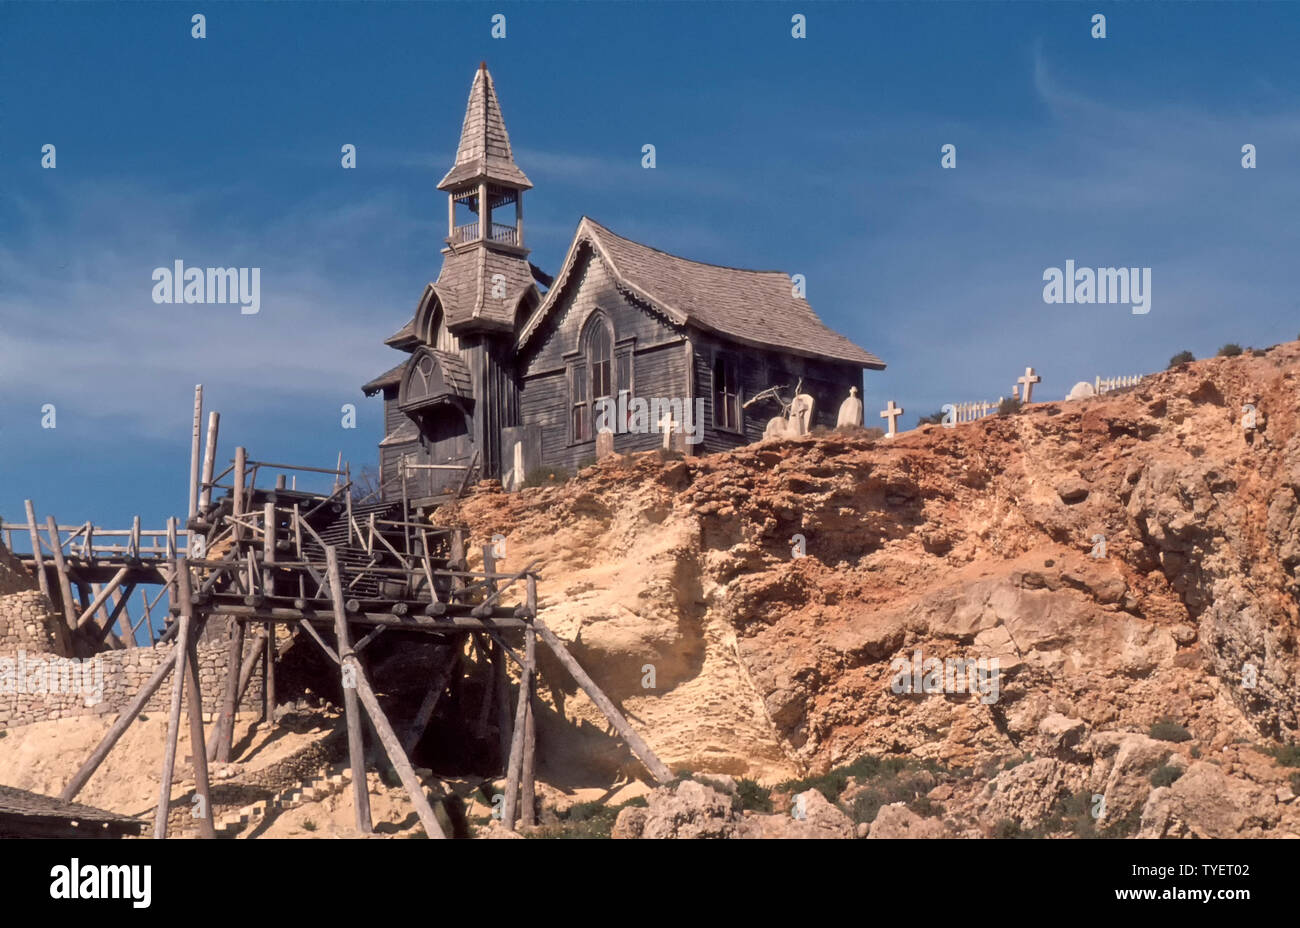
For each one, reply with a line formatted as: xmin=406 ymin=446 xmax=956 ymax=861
xmin=3 ymin=382 xmax=672 ymax=837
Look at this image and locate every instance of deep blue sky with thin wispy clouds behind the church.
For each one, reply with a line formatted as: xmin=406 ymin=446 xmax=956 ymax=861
xmin=0 ymin=0 xmax=1300 ymax=535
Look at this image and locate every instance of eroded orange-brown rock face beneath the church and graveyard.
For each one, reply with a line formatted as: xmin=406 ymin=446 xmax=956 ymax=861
xmin=449 ymin=343 xmax=1300 ymax=831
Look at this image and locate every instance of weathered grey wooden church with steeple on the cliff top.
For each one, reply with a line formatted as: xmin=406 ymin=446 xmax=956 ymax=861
xmin=361 ymin=65 xmax=884 ymax=499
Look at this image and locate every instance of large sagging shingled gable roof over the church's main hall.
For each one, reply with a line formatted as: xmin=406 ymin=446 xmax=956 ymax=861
xmin=519 ymin=216 xmax=885 ymax=370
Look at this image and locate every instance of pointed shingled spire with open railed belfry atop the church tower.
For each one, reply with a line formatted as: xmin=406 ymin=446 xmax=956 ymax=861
xmin=438 ymin=62 xmax=533 ymax=255
